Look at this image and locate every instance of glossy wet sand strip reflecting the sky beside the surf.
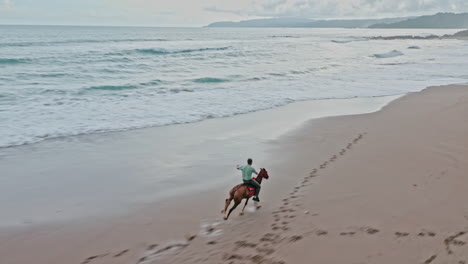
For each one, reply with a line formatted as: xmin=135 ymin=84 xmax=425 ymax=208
xmin=0 ymin=95 xmax=400 ymax=226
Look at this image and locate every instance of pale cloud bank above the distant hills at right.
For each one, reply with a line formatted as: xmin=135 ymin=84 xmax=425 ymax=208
xmin=205 ymin=0 xmax=468 ymax=18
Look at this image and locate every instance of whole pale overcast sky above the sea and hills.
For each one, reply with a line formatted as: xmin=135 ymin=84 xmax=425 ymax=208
xmin=0 ymin=0 xmax=468 ymax=26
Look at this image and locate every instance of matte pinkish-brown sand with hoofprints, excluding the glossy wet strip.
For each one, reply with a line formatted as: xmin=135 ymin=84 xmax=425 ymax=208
xmin=0 ymin=85 xmax=468 ymax=264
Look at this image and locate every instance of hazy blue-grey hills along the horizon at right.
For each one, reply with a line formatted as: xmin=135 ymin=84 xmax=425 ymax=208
xmin=207 ymin=13 xmax=468 ymax=28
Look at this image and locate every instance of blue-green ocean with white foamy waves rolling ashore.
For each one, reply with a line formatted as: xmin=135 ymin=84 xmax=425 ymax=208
xmin=0 ymin=26 xmax=468 ymax=147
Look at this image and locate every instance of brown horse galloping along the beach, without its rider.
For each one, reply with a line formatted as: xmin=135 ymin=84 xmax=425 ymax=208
xmin=223 ymin=169 xmax=270 ymax=220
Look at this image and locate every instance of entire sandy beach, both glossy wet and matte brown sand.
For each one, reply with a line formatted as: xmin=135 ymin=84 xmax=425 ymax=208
xmin=0 ymin=85 xmax=468 ymax=264
